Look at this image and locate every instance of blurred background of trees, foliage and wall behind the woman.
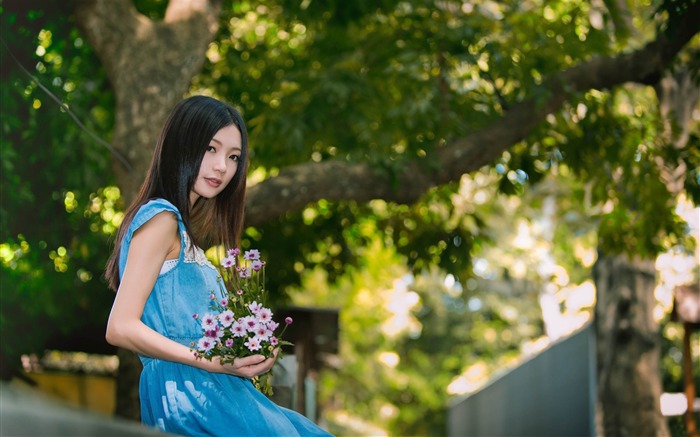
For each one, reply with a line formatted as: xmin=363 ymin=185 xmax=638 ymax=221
xmin=0 ymin=0 xmax=700 ymax=436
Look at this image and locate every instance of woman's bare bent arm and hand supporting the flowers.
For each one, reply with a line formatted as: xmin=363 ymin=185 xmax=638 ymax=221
xmin=106 ymin=213 xmax=275 ymax=378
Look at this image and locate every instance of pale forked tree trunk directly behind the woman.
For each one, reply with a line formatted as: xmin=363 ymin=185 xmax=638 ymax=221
xmin=75 ymin=0 xmax=220 ymax=420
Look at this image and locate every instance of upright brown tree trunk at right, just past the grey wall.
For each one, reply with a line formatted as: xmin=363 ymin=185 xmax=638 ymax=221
xmin=593 ymin=254 xmax=669 ymax=437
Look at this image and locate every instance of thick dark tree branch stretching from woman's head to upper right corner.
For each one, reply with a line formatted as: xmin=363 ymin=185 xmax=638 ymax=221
xmin=246 ymin=3 xmax=700 ymax=226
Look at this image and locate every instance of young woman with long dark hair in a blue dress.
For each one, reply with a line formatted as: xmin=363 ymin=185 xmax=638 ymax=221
xmin=105 ymin=96 xmax=328 ymax=436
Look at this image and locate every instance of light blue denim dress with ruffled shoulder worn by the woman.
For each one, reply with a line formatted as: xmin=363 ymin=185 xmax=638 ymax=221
xmin=119 ymin=199 xmax=329 ymax=436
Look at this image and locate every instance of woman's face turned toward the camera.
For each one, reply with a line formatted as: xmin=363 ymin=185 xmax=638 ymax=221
xmin=190 ymin=124 xmax=241 ymax=205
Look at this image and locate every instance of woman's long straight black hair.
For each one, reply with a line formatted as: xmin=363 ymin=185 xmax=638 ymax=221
xmin=105 ymin=96 xmax=248 ymax=291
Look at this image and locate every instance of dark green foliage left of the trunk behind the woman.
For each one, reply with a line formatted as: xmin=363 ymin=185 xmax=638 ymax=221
xmin=0 ymin=2 xmax=118 ymax=377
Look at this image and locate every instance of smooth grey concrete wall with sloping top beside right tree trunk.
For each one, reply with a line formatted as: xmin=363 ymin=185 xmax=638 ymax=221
xmin=447 ymin=325 xmax=595 ymax=437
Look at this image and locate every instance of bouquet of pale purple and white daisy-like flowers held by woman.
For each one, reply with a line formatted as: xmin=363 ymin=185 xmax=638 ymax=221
xmin=191 ymin=248 xmax=292 ymax=395
